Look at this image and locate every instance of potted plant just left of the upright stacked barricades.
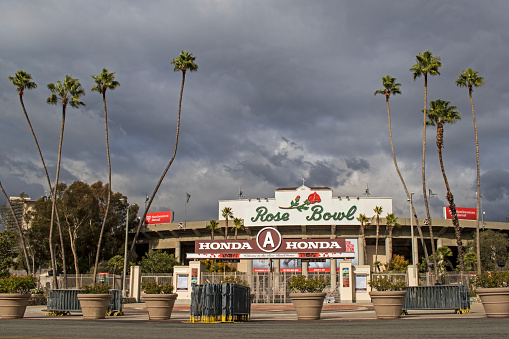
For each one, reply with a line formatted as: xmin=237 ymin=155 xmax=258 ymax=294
xmin=141 ymin=281 xmax=177 ymax=320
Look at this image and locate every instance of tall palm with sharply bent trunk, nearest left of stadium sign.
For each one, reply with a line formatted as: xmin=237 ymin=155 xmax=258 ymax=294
xmin=128 ymin=51 xmax=198 ymax=258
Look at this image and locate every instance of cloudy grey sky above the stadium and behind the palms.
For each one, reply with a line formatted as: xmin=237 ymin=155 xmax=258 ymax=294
xmin=0 ymin=0 xmax=509 ymax=226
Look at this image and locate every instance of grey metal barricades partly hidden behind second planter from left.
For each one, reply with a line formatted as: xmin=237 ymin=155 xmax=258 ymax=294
xmin=46 ymin=290 xmax=122 ymax=312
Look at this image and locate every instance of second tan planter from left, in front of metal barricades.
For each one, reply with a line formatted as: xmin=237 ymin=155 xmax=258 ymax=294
xmin=78 ymin=284 xmax=113 ymax=320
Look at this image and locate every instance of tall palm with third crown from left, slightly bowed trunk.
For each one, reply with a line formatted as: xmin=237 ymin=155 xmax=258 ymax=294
xmin=92 ymin=68 xmax=120 ymax=279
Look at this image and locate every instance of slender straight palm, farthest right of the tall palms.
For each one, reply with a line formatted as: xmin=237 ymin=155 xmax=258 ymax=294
xmin=456 ymin=68 xmax=484 ymax=275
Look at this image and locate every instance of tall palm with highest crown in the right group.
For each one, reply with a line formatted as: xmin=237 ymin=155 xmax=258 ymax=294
xmin=410 ymin=51 xmax=442 ymax=276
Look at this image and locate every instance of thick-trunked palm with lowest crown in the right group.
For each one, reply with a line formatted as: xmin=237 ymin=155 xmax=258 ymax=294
xmin=427 ymin=99 xmax=465 ymax=273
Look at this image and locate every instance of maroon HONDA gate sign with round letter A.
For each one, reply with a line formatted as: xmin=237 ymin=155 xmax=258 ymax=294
xmin=187 ymin=227 xmax=355 ymax=259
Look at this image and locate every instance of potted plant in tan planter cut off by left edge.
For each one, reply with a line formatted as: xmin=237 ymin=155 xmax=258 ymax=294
xmin=0 ymin=275 xmax=37 ymax=319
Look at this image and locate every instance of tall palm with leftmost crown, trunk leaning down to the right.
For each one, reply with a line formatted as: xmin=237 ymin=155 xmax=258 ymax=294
xmin=9 ymin=70 xmax=67 ymax=288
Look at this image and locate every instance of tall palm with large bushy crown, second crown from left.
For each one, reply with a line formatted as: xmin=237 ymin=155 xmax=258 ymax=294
xmin=46 ymin=75 xmax=85 ymax=288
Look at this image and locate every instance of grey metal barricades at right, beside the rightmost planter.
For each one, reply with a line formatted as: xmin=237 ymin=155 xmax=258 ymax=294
xmin=403 ymin=285 xmax=470 ymax=313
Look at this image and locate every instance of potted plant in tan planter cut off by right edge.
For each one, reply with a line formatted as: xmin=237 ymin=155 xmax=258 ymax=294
xmin=475 ymin=271 xmax=509 ymax=318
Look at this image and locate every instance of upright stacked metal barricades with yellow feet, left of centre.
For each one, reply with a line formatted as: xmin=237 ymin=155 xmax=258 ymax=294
xmin=191 ymin=283 xmax=251 ymax=323
